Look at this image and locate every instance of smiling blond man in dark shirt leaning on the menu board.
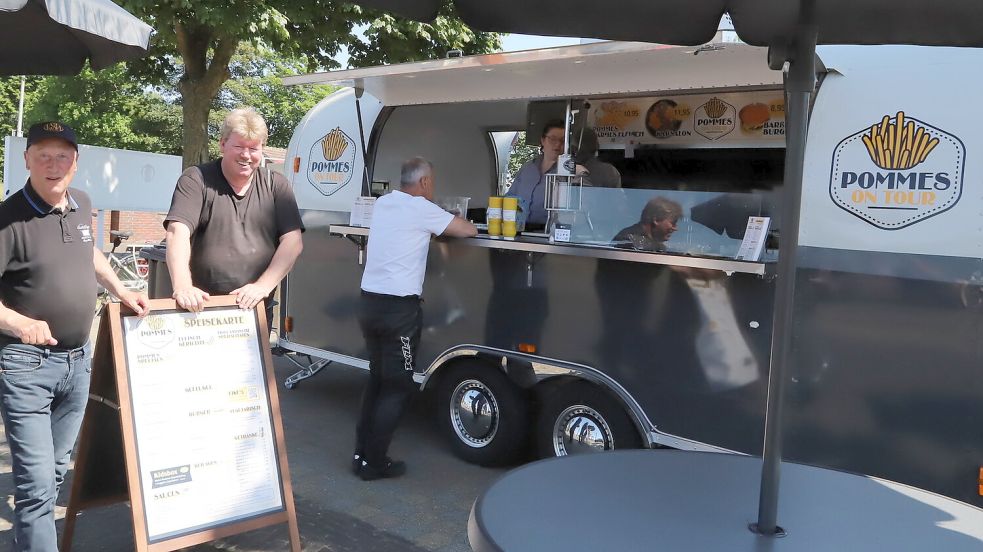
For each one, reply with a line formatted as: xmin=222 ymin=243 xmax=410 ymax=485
xmin=164 ymin=108 xmax=304 ymax=321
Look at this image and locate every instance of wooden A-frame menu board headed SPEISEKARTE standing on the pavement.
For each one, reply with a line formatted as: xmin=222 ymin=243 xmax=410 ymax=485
xmin=62 ymin=297 xmax=300 ymax=551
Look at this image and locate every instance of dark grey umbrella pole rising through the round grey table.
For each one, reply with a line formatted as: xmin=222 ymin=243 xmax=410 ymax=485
xmin=750 ymin=0 xmax=816 ymax=536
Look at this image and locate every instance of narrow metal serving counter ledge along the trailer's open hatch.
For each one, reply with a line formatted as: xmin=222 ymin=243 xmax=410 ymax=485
xmin=329 ymin=224 xmax=769 ymax=275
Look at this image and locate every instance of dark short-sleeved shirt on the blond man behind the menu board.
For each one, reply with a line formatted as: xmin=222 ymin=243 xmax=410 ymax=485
xmin=164 ymin=159 xmax=304 ymax=295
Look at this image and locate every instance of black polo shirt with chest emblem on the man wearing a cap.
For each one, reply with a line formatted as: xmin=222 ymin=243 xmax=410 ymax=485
xmin=0 ymin=182 xmax=96 ymax=349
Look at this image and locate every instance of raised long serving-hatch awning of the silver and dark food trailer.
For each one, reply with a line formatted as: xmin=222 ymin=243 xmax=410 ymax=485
xmin=284 ymin=42 xmax=782 ymax=106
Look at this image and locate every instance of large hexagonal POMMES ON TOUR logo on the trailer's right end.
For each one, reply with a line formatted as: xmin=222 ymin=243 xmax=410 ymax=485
xmin=829 ymin=111 xmax=966 ymax=230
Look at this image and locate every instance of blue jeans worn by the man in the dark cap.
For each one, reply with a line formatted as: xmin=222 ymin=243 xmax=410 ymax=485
xmin=0 ymin=343 xmax=92 ymax=552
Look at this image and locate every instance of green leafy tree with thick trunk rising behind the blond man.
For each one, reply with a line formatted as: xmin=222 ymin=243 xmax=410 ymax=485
xmin=120 ymin=0 xmax=499 ymax=166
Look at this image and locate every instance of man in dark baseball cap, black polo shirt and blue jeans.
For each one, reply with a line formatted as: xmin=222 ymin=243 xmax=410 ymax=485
xmin=0 ymin=121 xmax=148 ymax=552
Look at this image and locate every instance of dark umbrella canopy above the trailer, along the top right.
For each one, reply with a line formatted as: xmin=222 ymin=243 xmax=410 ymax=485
xmin=356 ymin=0 xmax=983 ymax=47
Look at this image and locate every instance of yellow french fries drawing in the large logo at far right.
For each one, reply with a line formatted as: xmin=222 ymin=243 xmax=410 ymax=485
xmin=863 ymin=111 xmax=939 ymax=170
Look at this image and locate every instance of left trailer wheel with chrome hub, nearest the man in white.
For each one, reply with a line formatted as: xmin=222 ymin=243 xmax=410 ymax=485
xmin=437 ymin=361 xmax=529 ymax=466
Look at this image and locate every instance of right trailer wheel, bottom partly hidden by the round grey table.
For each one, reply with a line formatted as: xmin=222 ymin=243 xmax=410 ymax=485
xmin=536 ymin=380 xmax=642 ymax=458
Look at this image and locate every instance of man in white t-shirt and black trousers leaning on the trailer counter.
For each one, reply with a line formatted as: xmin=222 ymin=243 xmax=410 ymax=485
xmin=352 ymin=157 xmax=478 ymax=481
